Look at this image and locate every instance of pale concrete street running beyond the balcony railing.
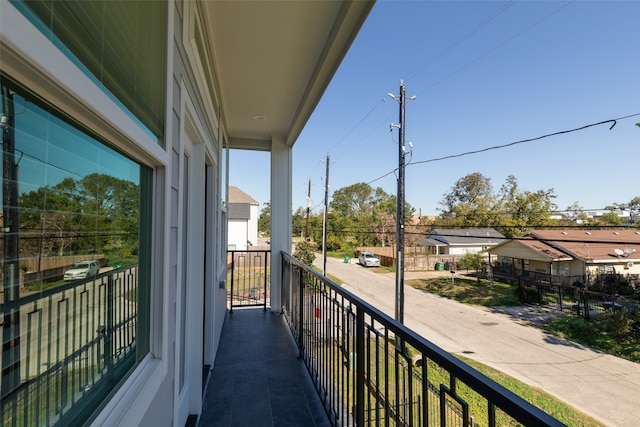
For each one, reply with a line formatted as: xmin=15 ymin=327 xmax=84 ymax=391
xmin=315 ymin=257 xmax=640 ymax=427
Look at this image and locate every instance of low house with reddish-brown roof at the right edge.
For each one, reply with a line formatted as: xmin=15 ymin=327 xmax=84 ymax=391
xmin=489 ymin=229 xmax=640 ymax=284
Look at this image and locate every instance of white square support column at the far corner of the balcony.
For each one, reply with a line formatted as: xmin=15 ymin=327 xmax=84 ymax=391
xmin=270 ymin=137 xmax=293 ymax=313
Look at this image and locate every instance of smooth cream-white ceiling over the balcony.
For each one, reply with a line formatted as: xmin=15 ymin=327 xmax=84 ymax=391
xmin=200 ymin=0 xmax=373 ymax=151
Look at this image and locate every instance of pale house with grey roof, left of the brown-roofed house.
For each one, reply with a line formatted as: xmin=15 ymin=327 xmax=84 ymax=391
xmin=416 ymin=228 xmax=505 ymax=255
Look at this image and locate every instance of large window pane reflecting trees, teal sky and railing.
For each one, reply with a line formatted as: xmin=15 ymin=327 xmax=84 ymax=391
xmin=0 ymin=80 xmax=151 ymax=426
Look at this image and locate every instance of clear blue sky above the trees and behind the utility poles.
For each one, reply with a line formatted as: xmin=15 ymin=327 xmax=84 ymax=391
xmin=229 ymin=1 xmax=640 ymax=215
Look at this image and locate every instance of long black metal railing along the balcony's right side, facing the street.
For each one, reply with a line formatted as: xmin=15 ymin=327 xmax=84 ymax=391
xmin=282 ymin=253 xmax=564 ymax=426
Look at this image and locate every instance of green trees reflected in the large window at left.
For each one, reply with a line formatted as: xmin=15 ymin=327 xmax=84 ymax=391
xmin=20 ymin=173 xmax=140 ymax=256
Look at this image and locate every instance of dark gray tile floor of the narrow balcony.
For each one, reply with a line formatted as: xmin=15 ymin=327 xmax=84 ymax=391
xmin=198 ymin=309 xmax=330 ymax=427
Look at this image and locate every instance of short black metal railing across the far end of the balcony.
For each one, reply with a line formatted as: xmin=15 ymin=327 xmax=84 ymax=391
xmin=227 ymin=250 xmax=271 ymax=311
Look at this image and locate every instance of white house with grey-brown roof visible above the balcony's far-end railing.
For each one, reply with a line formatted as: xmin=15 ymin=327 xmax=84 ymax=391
xmin=228 ymin=186 xmax=259 ymax=250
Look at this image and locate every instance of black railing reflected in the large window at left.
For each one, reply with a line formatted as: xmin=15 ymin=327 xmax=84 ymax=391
xmin=0 ymin=265 xmax=138 ymax=426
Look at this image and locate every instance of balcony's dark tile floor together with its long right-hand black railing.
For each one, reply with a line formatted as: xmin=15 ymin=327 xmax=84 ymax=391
xmin=200 ymin=253 xmax=563 ymax=426
